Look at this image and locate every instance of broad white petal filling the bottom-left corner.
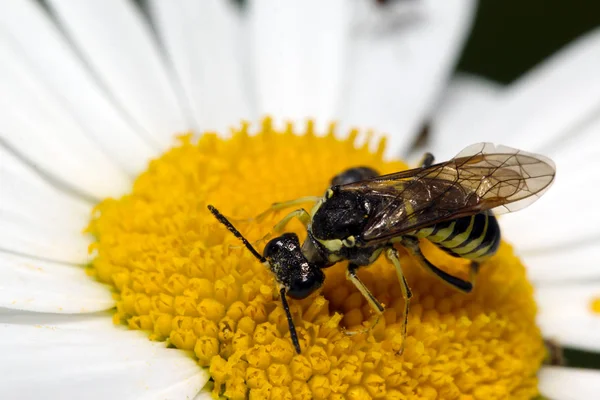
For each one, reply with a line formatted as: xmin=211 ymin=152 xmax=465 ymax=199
xmin=0 ymin=318 xmax=208 ymax=399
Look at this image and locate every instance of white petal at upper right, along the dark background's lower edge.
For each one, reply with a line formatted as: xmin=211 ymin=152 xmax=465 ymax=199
xmin=462 ymin=30 xmax=600 ymax=151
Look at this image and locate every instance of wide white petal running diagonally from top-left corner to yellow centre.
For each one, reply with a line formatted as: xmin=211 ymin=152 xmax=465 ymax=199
xmin=0 ymin=0 xmax=154 ymax=194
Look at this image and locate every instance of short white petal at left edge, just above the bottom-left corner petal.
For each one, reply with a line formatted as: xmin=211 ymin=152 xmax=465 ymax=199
xmin=0 ymin=252 xmax=115 ymax=316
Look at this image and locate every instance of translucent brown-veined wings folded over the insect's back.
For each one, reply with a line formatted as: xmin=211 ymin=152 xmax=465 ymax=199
xmin=340 ymin=143 xmax=555 ymax=244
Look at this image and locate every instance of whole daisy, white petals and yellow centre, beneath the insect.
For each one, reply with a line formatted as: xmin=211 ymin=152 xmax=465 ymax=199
xmin=0 ymin=0 xmax=600 ymax=399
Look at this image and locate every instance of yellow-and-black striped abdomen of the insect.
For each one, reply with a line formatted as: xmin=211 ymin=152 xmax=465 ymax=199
xmin=415 ymin=212 xmax=500 ymax=261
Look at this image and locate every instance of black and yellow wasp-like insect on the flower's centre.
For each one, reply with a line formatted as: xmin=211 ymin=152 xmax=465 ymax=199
xmin=208 ymin=143 xmax=556 ymax=353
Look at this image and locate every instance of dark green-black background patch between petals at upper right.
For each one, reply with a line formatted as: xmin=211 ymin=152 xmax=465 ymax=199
xmin=458 ymin=0 xmax=600 ymax=83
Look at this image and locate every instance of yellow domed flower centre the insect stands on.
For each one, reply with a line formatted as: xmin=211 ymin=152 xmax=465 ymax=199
xmin=88 ymin=119 xmax=545 ymax=400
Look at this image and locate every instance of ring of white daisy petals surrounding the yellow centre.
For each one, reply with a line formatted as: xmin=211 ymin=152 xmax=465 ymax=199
xmin=0 ymin=0 xmax=600 ymax=399
